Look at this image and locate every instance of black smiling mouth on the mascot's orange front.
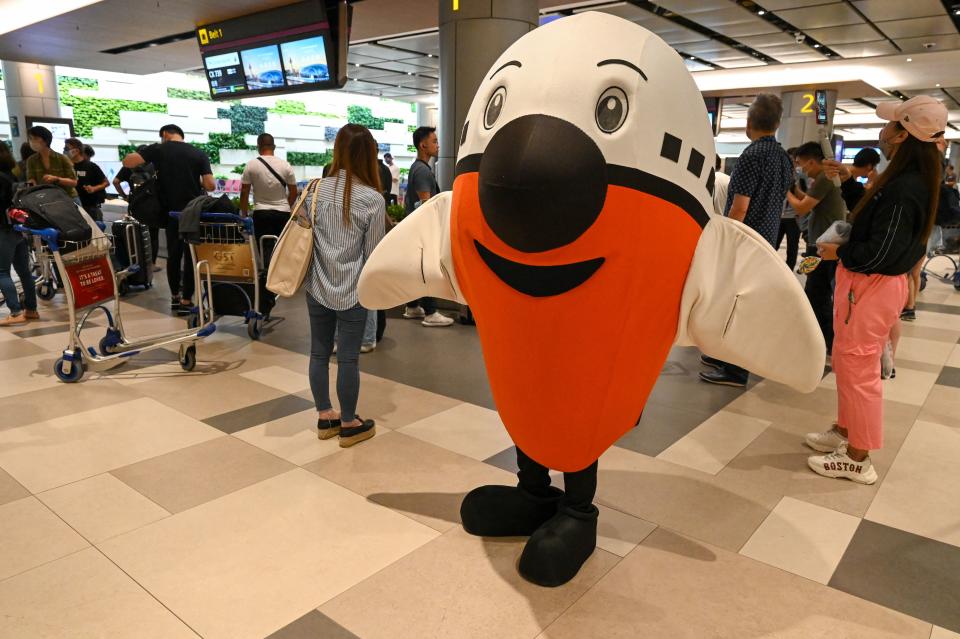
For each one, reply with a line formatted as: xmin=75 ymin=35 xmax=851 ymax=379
xmin=473 ymin=240 xmax=604 ymax=297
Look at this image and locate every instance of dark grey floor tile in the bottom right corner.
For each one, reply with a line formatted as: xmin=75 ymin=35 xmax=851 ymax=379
xmin=830 ymin=520 xmax=960 ymax=632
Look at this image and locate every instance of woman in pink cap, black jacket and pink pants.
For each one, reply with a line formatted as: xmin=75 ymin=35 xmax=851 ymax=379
xmin=805 ymin=96 xmax=947 ymax=484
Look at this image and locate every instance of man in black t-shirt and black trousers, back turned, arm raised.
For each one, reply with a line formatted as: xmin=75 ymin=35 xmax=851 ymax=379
xmin=123 ymin=124 xmax=216 ymax=312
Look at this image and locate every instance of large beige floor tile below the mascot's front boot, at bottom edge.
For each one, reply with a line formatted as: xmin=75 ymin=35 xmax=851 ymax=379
xmin=320 ymin=527 xmax=618 ymax=639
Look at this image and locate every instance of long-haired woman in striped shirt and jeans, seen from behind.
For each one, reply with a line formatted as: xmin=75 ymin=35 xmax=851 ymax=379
xmin=304 ymin=124 xmax=386 ymax=448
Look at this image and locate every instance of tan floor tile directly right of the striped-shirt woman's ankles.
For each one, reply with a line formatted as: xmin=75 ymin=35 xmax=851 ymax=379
xmin=359 ymin=376 xmax=464 ymax=430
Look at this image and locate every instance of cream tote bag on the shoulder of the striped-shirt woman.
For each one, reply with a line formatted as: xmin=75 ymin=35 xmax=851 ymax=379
xmin=267 ymin=180 xmax=320 ymax=297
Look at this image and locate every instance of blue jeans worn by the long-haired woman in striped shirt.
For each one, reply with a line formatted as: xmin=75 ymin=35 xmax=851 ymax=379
xmin=307 ymin=293 xmax=368 ymax=424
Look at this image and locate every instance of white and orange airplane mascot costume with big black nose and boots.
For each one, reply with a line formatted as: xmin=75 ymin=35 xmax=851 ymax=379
xmin=359 ymin=12 xmax=825 ymax=586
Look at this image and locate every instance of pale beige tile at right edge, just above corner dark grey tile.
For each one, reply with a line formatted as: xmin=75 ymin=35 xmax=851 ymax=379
xmin=866 ymin=421 xmax=960 ymax=546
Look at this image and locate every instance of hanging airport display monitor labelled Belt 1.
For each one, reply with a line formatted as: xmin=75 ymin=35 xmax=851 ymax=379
xmin=197 ymin=0 xmax=351 ymax=100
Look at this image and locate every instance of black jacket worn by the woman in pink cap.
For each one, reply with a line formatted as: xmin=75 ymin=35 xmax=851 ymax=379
xmin=837 ymin=170 xmax=930 ymax=275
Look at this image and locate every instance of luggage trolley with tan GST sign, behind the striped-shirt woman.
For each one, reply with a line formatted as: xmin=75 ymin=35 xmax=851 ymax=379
xmin=176 ymin=211 xmax=277 ymax=340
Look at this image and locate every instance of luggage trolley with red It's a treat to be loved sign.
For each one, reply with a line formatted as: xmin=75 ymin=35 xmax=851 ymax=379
xmin=14 ymin=226 xmax=217 ymax=382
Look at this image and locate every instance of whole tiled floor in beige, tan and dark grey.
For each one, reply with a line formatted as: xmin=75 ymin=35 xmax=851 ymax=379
xmin=0 ymin=262 xmax=960 ymax=639
